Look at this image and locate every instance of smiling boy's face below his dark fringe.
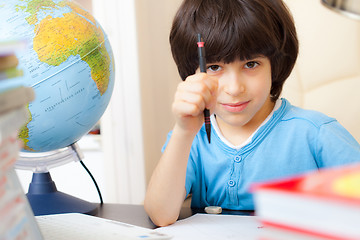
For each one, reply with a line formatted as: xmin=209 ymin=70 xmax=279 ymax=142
xmin=207 ymin=56 xmax=274 ymax=129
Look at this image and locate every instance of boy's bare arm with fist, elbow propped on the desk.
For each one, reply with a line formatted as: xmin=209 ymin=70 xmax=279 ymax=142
xmin=144 ymin=73 xmax=218 ymax=226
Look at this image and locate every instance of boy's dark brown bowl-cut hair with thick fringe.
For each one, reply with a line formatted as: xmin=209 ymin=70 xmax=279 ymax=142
xmin=170 ymin=0 xmax=298 ymax=100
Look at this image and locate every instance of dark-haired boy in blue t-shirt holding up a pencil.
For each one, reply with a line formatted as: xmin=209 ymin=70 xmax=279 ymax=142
xmin=145 ymin=0 xmax=360 ymax=226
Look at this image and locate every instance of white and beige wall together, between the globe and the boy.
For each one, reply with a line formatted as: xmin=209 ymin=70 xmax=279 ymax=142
xmin=87 ymin=0 xmax=181 ymax=203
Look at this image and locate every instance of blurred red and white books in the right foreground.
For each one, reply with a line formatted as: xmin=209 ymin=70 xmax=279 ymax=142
xmin=253 ymin=164 xmax=360 ymax=240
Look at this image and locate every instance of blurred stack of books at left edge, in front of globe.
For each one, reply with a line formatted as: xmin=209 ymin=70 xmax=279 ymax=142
xmin=0 ymin=42 xmax=40 ymax=240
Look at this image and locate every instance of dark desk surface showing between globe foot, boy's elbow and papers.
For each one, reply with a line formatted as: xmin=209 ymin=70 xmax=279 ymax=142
xmin=95 ymin=203 xmax=254 ymax=229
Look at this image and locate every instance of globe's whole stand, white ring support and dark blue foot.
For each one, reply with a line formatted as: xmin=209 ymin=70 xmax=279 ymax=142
xmin=16 ymin=143 xmax=98 ymax=216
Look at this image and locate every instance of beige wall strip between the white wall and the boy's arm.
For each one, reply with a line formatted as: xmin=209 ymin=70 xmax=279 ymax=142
xmin=136 ymin=0 xmax=182 ymax=182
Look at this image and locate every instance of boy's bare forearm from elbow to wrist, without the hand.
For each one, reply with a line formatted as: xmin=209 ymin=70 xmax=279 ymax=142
xmin=145 ymin=127 xmax=194 ymax=226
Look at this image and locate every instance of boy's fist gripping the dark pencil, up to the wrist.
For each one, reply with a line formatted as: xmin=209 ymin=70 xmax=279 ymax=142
xmin=172 ymin=73 xmax=218 ymax=135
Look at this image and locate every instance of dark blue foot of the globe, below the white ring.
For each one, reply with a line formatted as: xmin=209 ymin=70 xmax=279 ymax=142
xmin=26 ymin=172 xmax=99 ymax=216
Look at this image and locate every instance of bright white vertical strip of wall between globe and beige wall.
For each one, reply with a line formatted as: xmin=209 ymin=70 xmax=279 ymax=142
xmin=92 ymin=0 xmax=146 ymax=204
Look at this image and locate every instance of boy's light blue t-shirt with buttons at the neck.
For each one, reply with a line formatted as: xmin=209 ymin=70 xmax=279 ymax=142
xmin=163 ymin=99 xmax=360 ymax=210
